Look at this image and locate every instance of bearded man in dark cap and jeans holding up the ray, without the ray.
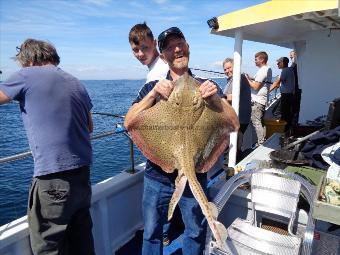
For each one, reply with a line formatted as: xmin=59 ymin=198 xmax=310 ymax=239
xmin=124 ymin=27 xmax=239 ymax=255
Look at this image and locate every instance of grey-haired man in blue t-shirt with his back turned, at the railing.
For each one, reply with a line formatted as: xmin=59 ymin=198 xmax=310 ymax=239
xmin=0 ymin=39 xmax=95 ymax=254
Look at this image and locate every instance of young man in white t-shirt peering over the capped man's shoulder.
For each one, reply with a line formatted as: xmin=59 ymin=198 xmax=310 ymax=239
xmin=129 ymin=22 xmax=169 ymax=83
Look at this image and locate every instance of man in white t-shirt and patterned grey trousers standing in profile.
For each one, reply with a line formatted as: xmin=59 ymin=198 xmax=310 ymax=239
xmin=246 ymin=51 xmax=272 ymax=145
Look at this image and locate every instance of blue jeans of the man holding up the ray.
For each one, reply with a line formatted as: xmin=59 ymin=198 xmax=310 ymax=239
xmin=142 ymin=177 xmax=207 ymax=255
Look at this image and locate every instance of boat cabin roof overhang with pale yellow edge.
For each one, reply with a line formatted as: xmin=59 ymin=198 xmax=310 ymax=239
xmin=211 ymin=0 xmax=340 ymax=48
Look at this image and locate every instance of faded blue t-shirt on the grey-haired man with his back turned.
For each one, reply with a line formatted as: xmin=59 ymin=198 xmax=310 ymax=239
xmin=0 ymin=65 xmax=92 ymax=176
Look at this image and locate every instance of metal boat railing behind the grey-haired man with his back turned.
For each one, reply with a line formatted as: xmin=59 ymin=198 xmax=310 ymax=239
xmin=0 ymin=112 xmax=136 ymax=173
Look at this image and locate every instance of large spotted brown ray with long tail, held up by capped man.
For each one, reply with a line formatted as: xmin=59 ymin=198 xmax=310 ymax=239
xmin=128 ymin=73 xmax=234 ymax=246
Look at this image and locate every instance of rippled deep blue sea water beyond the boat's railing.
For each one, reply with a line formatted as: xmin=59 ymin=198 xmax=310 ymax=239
xmin=0 ymin=79 xmax=226 ymax=226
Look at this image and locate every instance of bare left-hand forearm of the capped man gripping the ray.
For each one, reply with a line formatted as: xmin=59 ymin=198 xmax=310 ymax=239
xmin=124 ymin=89 xmax=157 ymax=129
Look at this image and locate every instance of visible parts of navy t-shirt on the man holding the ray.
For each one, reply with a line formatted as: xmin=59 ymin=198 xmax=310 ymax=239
xmin=132 ymin=70 xmax=223 ymax=183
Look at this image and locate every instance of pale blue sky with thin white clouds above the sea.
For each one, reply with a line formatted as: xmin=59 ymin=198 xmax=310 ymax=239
xmin=0 ymin=0 xmax=290 ymax=80
